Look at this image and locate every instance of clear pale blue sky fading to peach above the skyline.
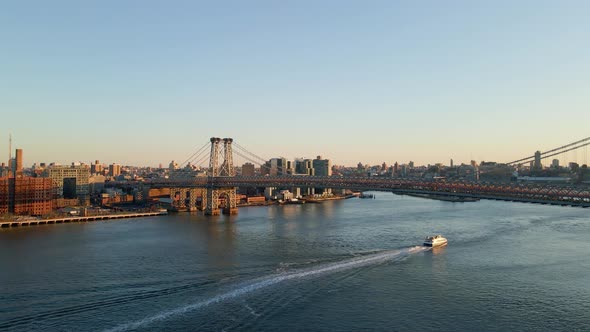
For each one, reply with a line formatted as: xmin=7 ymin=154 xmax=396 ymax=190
xmin=0 ymin=0 xmax=590 ymax=165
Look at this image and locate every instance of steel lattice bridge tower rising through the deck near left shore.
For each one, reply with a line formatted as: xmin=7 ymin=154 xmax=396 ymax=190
xmin=204 ymin=137 xmax=238 ymax=216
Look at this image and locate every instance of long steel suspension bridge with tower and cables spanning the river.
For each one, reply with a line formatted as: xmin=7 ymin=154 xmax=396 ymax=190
xmin=114 ymin=137 xmax=590 ymax=215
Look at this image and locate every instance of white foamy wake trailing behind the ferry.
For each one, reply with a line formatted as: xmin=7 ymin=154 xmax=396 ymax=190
xmin=105 ymin=246 xmax=431 ymax=332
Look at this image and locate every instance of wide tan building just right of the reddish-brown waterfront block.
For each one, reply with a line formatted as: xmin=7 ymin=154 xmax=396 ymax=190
xmin=43 ymin=165 xmax=90 ymax=200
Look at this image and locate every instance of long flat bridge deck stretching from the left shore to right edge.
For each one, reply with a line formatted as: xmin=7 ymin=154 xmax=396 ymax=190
xmin=122 ymin=175 xmax=590 ymax=207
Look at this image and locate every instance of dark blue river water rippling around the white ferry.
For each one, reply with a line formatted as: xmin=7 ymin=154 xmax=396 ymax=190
xmin=0 ymin=193 xmax=590 ymax=331
